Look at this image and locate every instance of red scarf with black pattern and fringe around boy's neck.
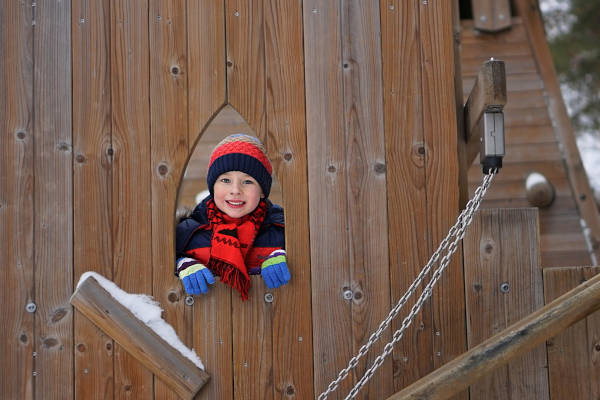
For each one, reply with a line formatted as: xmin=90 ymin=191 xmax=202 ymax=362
xmin=206 ymin=199 xmax=267 ymax=300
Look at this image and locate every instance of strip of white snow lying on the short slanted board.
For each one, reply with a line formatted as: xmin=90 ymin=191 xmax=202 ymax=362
xmin=77 ymin=271 xmax=204 ymax=370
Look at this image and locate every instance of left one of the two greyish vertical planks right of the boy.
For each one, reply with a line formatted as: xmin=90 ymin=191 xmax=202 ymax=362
xmin=303 ymin=0 xmax=353 ymax=399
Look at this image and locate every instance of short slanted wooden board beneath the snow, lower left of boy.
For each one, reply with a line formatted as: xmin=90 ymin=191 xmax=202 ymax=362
xmin=71 ymin=277 xmax=210 ymax=399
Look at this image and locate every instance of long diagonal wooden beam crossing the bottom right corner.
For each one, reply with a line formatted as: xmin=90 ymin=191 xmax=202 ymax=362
xmin=388 ymin=262 xmax=600 ymax=400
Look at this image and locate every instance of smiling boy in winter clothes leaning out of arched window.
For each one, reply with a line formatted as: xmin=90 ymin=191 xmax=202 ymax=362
xmin=175 ymin=134 xmax=290 ymax=300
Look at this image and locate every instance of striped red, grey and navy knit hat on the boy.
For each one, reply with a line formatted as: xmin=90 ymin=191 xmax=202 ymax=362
xmin=206 ymin=133 xmax=273 ymax=198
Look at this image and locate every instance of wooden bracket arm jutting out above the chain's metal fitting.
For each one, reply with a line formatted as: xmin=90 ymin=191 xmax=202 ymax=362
xmin=465 ymin=60 xmax=506 ymax=165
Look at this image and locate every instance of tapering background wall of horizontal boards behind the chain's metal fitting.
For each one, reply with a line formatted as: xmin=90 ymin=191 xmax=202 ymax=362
xmin=461 ymin=17 xmax=591 ymax=267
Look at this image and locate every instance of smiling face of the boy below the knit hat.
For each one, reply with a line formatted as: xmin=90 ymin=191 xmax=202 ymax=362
xmin=213 ymin=171 xmax=263 ymax=218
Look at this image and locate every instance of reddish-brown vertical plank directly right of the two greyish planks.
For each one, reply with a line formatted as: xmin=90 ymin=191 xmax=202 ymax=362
xmin=380 ymin=0 xmax=433 ymax=391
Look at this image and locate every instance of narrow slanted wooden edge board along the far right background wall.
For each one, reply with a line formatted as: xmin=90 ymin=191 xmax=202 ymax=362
xmin=515 ymin=0 xmax=600 ymax=258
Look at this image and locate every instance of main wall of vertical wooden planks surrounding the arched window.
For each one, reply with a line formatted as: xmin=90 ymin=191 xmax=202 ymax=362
xmin=0 ymin=0 xmax=466 ymax=399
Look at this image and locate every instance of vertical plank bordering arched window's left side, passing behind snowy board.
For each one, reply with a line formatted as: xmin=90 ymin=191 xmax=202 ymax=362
xmin=148 ymin=0 xmax=192 ymax=399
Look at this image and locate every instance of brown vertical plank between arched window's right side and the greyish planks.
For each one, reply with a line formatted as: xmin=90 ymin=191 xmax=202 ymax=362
xmin=265 ymin=0 xmax=314 ymax=399
